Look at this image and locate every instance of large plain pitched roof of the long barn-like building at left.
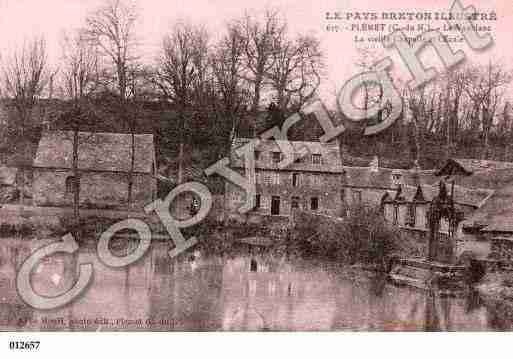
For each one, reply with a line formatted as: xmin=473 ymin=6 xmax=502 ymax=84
xmin=34 ymin=131 xmax=155 ymax=173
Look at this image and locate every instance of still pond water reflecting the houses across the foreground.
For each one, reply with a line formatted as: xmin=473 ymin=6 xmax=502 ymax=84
xmin=0 ymin=239 xmax=511 ymax=331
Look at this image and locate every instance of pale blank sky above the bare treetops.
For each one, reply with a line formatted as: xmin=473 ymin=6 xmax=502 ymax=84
xmin=0 ymin=0 xmax=513 ymax=105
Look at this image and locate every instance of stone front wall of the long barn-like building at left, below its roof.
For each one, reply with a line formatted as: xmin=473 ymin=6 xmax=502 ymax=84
xmin=33 ymin=169 xmax=156 ymax=209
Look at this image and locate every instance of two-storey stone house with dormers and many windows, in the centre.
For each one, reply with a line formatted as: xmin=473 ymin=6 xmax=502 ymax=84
xmin=225 ymin=139 xmax=342 ymax=218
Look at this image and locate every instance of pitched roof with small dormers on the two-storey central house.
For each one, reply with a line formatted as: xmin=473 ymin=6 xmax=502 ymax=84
xmin=231 ymin=138 xmax=343 ymax=173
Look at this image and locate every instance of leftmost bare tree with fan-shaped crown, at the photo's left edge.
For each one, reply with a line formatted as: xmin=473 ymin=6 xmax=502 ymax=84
xmin=1 ymin=37 xmax=51 ymax=205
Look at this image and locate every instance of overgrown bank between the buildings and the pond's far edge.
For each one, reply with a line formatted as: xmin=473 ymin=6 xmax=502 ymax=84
xmin=0 ymin=205 xmax=423 ymax=271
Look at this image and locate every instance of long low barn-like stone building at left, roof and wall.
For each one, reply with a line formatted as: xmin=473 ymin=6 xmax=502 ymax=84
xmin=33 ymin=131 xmax=157 ymax=210
